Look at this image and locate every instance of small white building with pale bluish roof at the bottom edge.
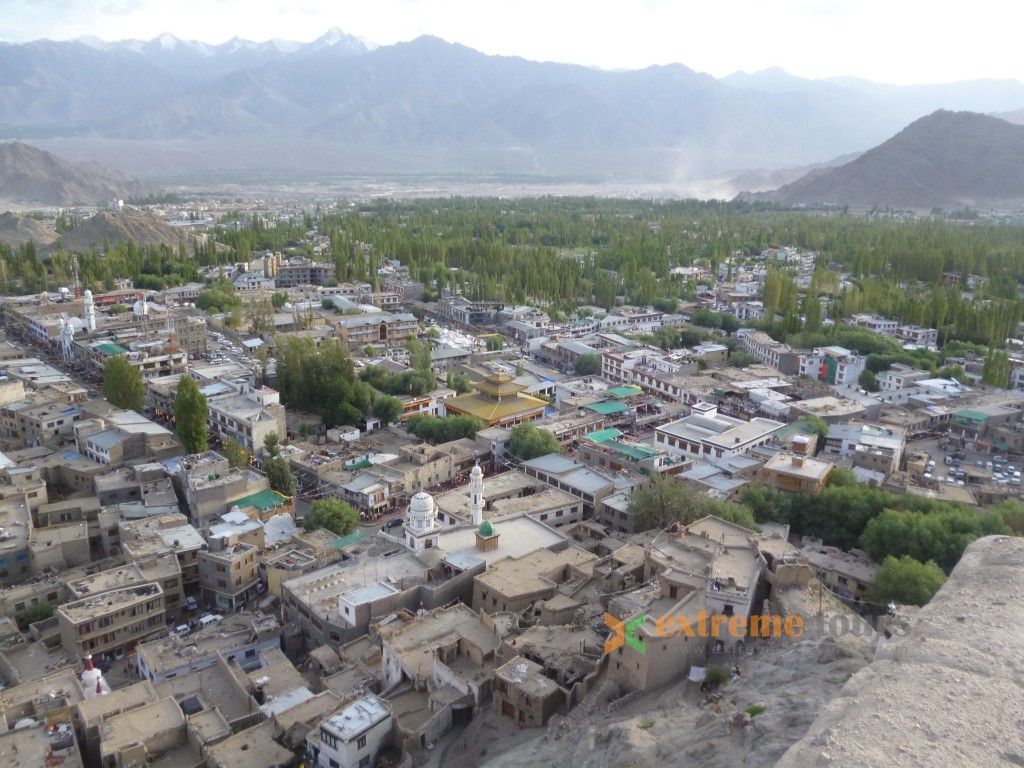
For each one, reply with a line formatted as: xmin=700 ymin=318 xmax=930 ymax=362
xmin=306 ymin=694 xmax=391 ymax=768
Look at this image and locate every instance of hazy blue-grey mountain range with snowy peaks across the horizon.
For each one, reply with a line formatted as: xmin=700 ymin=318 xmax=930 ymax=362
xmin=8 ymin=30 xmax=1024 ymax=188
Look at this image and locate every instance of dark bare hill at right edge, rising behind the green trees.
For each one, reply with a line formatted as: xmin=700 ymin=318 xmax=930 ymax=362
xmin=740 ymin=110 xmax=1024 ymax=210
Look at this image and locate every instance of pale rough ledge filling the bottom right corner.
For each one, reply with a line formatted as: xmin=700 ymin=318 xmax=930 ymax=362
xmin=777 ymin=537 xmax=1024 ymax=768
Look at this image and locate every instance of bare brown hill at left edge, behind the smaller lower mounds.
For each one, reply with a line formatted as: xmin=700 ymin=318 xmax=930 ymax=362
xmin=0 ymin=141 xmax=158 ymax=206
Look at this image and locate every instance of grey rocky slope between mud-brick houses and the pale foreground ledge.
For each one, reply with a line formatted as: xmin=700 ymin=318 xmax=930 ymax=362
xmin=452 ymin=583 xmax=884 ymax=768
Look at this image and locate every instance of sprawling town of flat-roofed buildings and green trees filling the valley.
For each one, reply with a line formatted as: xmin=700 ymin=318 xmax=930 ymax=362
xmin=0 ymin=199 xmax=1024 ymax=768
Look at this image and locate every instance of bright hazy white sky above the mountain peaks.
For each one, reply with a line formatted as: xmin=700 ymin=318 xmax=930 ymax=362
xmin=0 ymin=0 xmax=1024 ymax=85
